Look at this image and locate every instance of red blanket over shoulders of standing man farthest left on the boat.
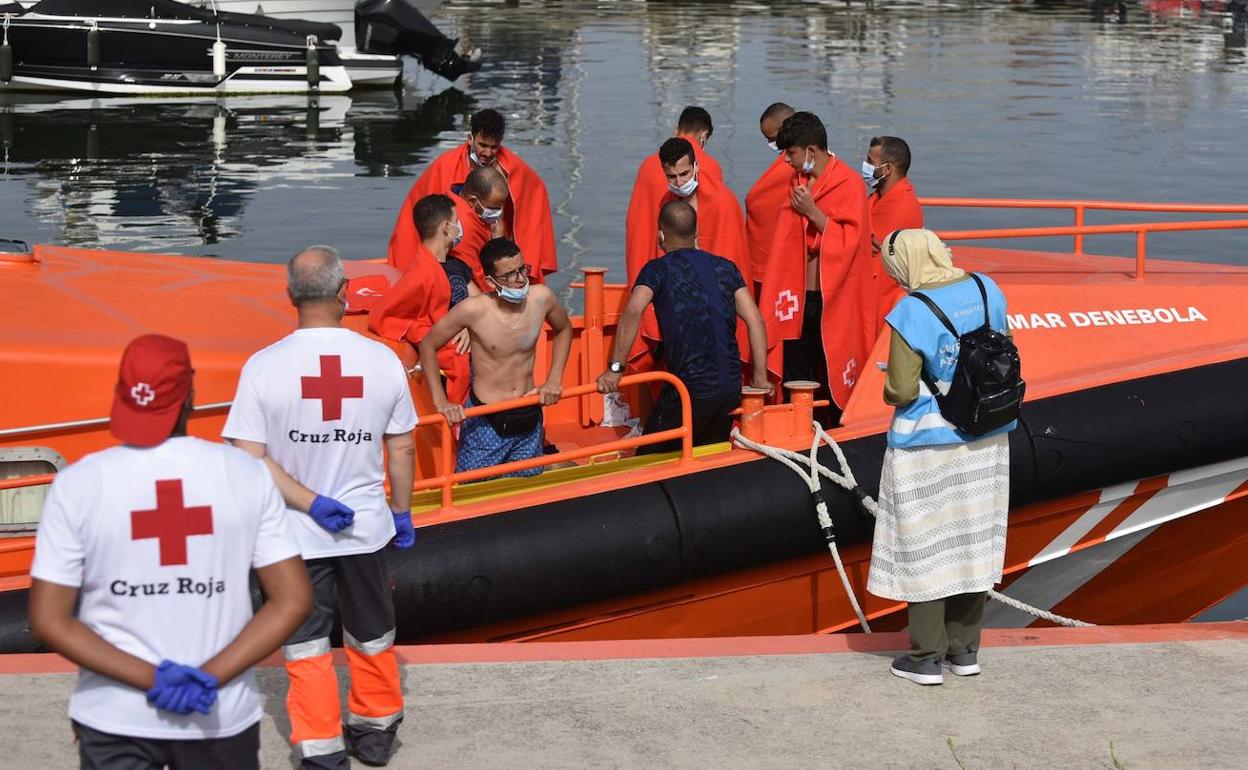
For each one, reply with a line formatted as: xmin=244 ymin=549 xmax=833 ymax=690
xmin=387 ymin=142 xmax=559 ymax=283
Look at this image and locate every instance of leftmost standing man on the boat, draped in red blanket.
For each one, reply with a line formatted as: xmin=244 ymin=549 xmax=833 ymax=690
xmin=388 ymin=110 xmax=559 ymax=283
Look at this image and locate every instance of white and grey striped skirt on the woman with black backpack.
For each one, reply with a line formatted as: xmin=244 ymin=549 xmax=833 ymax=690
xmin=866 ymin=434 xmax=1010 ymax=602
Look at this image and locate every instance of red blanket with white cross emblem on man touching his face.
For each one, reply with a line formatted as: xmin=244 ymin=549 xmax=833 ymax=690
xmin=759 ymin=158 xmax=879 ymax=408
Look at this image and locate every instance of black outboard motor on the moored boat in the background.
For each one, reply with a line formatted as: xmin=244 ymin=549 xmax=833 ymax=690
xmin=356 ymin=0 xmax=480 ymax=80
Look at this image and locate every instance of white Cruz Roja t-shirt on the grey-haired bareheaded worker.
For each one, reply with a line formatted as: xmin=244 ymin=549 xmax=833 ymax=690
xmin=221 ymin=328 xmax=416 ymax=559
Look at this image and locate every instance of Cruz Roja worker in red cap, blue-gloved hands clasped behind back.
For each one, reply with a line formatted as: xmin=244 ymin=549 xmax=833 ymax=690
xmin=30 ymin=334 xmax=312 ymax=770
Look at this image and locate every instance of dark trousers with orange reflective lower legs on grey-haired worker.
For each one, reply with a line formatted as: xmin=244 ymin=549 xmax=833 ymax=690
xmin=282 ymin=553 xmax=403 ymax=768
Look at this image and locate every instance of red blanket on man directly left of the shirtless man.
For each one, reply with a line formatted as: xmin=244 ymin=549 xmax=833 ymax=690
xmin=368 ymin=241 xmax=472 ymax=403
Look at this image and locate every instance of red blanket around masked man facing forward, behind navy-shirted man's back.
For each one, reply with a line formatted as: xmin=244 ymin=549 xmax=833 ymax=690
xmin=624 ymin=142 xmax=750 ymax=369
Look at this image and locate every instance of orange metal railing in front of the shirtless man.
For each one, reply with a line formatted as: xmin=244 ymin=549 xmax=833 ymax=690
xmin=416 ymin=372 xmax=694 ymax=508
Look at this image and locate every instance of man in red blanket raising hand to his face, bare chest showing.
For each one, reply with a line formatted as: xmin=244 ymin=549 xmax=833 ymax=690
xmin=759 ymin=112 xmax=877 ymax=427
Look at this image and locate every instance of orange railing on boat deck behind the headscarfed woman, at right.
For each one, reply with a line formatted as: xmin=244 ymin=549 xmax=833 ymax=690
xmin=919 ymin=197 xmax=1248 ymax=278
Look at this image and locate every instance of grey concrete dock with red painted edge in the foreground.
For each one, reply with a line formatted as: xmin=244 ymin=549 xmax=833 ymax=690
xmin=0 ymin=623 xmax=1248 ymax=770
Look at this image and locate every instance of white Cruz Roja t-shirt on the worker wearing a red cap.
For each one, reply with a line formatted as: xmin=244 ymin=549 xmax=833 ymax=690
xmin=30 ymin=437 xmax=300 ymax=739
